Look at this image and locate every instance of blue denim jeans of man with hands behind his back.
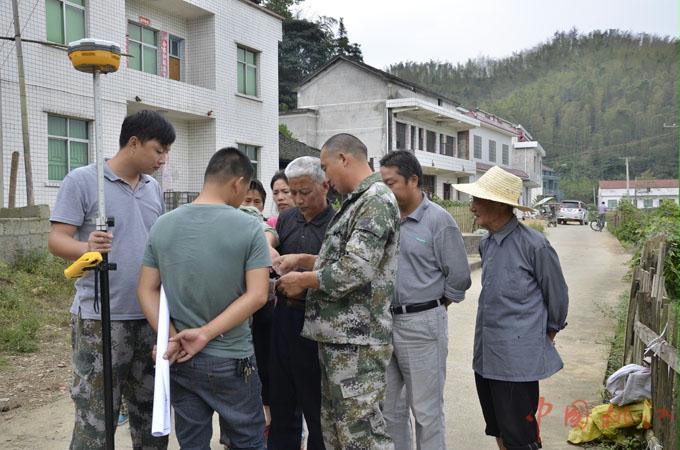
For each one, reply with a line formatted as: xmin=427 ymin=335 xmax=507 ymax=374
xmin=170 ymin=353 xmax=266 ymax=450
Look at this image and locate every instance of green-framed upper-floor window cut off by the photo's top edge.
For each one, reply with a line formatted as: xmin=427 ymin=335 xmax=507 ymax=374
xmin=45 ymin=0 xmax=85 ymax=44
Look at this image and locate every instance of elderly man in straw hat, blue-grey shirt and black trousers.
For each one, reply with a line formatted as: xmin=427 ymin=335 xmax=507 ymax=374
xmin=454 ymin=166 xmax=569 ymax=450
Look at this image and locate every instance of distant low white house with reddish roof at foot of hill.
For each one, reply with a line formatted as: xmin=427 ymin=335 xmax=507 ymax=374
xmin=597 ymin=180 xmax=680 ymax=209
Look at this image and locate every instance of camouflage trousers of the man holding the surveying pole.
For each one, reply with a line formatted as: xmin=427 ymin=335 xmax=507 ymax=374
xmin=70 ymin=314 xmax=168 ymax=450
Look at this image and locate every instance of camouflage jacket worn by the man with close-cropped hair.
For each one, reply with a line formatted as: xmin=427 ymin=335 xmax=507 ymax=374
xmin=302 ymin=173 xmax=399 ymax=345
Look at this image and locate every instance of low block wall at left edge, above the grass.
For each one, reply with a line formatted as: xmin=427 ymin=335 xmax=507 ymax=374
xmin=0 ymin=205 xmax=50 ymax=263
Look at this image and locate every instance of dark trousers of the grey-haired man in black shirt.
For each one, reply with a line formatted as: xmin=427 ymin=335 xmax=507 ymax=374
xmin=267 ymin=300 xmax=324 ymax=450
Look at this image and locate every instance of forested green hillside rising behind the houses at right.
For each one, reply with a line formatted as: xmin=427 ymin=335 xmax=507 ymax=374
xmin=388 ymin=30 xmax=680 ymax=197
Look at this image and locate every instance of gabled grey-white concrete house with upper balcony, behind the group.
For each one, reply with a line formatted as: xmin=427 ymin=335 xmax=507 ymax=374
xmin=280 ymin=56 xmax=480 ymax=200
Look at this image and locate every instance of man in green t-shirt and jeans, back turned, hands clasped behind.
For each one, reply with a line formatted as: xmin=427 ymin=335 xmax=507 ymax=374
xmin=137 ymin=148 xmax=271 ymax=449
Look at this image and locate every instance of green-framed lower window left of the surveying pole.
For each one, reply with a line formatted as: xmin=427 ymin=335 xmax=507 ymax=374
xmin=47 ymin=115 xmax=90 ymax=181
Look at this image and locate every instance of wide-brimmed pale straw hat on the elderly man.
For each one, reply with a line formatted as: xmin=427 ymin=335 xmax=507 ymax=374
xmin=453 ymin=166 xmax=533 ymax=211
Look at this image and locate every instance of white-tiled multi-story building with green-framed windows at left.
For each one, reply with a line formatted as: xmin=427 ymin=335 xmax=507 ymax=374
xmin=0 ymin=0 xmax=282 ymax=212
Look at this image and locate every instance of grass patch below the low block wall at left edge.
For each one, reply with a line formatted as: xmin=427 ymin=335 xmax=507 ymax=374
xmin=0 ymin=250 xmax=75 ymax=357
